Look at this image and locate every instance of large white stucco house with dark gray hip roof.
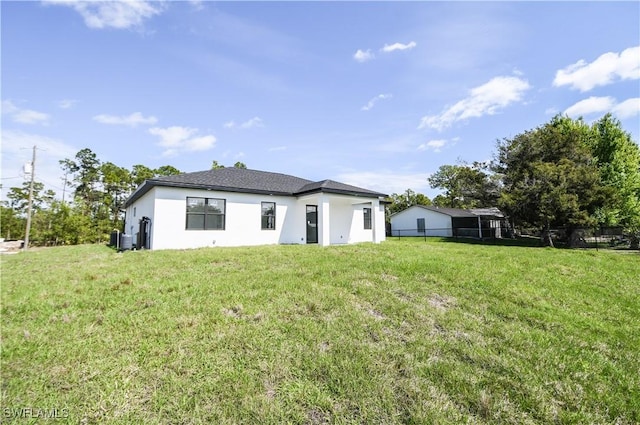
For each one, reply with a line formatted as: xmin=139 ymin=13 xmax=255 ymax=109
xmin=123 ymin=168 xmax=386 ymax=249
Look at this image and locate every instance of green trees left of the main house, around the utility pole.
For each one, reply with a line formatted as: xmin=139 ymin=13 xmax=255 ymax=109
xmin=0 ymin=156 xmax=246 ymax=245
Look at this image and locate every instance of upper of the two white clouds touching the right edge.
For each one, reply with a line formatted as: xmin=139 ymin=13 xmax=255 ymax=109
xmin=553 ymin=46 xmax=640 ymax=92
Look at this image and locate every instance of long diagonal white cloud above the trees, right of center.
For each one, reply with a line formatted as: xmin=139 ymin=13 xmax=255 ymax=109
xmin=418 ymin=77 xmax=531 ymax=131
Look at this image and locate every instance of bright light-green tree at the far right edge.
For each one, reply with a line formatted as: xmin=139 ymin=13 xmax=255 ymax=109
xmin=589 ymin=114 xmax=640 ymax=249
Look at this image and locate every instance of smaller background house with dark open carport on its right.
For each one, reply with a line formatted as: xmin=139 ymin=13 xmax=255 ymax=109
xmin=390 ymin=205 xmax=504 ymax=238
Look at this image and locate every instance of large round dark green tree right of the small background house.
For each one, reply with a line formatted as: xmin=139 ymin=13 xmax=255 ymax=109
xmin=496 ymin=115 xmax=605 ymax=246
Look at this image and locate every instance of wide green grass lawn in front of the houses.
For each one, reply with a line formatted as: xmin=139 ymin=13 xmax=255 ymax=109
xmin=1 ymin=238 xmax=640 ymax=424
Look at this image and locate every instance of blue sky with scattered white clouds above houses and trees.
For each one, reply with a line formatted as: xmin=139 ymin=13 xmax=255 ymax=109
xmin=0 ymin=0 xmax=640 ymax=199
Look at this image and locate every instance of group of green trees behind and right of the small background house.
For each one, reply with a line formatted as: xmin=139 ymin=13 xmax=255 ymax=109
xmin=388 ymin=114 xmax=640 ymax=249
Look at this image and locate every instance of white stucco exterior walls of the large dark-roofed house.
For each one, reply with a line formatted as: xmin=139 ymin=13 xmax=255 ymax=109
xmin=125 ymin=186 xmax=385 ymax=249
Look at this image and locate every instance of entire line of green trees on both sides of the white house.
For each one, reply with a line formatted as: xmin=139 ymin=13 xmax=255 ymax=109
xmin=0 ymin=114 xmax=640 ymax=248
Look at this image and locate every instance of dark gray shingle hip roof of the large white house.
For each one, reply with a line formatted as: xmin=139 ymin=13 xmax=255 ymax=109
xmin=125 ymin=167 xmax=386 ymax=207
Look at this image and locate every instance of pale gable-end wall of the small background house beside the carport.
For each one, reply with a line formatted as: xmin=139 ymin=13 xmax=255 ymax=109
xmin=391 ymin=206 xmax=453 ymax=237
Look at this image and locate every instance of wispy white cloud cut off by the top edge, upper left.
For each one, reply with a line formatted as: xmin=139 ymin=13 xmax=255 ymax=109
xmin=44 ymin=0 xmax=163 ymax=29
